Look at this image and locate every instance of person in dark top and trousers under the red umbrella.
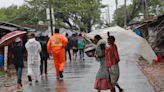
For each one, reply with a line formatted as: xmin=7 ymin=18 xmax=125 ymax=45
xmin=12 ymin=37 xmax=24 ymax=90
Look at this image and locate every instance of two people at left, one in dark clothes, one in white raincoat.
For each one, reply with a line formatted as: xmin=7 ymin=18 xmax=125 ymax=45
xmin=12 ymin=34 xmax=47 ymax=89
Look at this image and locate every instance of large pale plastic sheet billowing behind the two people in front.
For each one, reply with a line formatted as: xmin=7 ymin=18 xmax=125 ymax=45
xmin=86 ymin=26 xmax=156 ymax=64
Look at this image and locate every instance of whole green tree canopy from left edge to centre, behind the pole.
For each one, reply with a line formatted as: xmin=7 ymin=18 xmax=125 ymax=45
xmin=0 ymin=0 xmax=103 ymax=32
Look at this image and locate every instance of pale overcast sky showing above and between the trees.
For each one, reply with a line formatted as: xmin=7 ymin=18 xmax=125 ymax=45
xmin=0 ymin=0 xmax=131 ymax=20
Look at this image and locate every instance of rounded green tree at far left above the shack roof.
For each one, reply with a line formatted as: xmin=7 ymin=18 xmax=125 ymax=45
xmin=0 ymin=5 xmax=45 ymax=25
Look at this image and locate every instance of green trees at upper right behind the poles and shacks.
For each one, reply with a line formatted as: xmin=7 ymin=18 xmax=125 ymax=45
xmin=114 ymin=0 xmax=164 ymax=26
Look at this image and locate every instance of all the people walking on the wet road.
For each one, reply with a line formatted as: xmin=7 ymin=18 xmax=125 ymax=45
xmin=12 ymin=29 xmax=123 ymax=92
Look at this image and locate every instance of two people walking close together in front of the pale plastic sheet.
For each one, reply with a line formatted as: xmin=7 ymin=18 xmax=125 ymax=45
xmin=92 ymin=32 xmax=123 ymax=92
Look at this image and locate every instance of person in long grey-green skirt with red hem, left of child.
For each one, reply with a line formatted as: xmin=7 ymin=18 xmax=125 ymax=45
xmin=93 ymin=35 xmax=112 ymax=92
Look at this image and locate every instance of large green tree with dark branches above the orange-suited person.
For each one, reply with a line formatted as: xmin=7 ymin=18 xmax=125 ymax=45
xmin=24 ymin=0 xmax=102 ymax=32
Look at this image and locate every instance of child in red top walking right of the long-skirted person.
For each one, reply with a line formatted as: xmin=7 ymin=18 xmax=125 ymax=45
xmin=105 ymin=33 xmax=123 ymax=92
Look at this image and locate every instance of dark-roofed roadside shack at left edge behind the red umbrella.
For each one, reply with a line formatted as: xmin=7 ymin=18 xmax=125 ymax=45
xmin=0 ymin=22 xmax=32 ymax=71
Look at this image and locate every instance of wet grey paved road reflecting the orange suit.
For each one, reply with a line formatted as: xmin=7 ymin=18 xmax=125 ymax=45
xmin=23 ymin=57 xmax=154 ymax=92
